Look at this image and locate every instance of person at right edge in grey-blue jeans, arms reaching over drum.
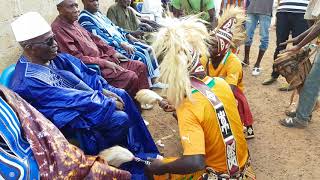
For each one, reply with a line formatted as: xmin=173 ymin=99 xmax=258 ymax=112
xmin=280 ymin=0 xmax=320 ymax=128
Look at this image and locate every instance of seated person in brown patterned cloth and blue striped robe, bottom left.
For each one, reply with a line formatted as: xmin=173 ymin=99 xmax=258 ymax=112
xmin=0 ymin=85 xmax=131 ymax=180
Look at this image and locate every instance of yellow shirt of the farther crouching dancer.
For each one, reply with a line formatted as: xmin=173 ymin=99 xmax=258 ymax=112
xmin=200 ymin=52 xmax=244 ymax=92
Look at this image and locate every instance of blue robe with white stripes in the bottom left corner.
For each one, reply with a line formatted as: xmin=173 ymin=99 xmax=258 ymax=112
xmin=0 ymin=97 xmax=40 ymax=180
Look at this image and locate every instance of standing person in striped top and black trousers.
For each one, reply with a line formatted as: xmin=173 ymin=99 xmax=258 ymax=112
xmin=262 ymin=0 xmax=309 ymax=91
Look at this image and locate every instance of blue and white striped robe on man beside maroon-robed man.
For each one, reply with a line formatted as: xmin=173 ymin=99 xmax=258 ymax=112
xmin=79 ymin=10 xmax=160 ymax=78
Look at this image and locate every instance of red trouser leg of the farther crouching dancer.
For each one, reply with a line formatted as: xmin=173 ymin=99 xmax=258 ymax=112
xmin=233 ymin=87 xmax=253 ymax=127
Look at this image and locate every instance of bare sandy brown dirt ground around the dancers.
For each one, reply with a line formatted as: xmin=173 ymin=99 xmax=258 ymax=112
xmin=143 ymin=29 xmax=320 ymax=180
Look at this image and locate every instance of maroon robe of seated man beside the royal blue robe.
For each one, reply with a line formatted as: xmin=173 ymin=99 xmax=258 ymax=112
xmin=51 ymin=16 xmax=149 ymax=97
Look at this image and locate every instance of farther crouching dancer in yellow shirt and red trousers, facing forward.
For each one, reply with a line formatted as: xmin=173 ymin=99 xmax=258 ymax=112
xmin=201 ymin=7 xmax=254 ymax=138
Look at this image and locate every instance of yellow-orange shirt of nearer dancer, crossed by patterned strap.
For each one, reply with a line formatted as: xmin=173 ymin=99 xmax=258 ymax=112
xmin=177 ymin=77 xmax=248 ymax=173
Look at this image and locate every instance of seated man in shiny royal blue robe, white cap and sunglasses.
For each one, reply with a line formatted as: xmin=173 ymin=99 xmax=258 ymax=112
xmin=10 ymin=12 xmax=159 ymax=179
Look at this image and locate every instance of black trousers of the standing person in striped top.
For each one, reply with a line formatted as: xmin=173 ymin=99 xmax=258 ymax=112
xmin=271 ymin=12 xmax=308 ymax=78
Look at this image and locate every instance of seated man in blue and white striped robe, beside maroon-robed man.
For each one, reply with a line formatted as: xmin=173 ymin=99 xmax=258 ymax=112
xmin=79 ymin=0 xmax=161 ymax=87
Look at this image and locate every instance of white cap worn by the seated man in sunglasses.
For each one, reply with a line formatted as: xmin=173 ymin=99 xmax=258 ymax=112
xmin=11 ymin=12 xmax=51 ymax=42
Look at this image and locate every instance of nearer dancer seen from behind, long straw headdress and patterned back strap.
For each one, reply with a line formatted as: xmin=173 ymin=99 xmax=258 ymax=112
xmin=147 ymin=17 xmax=255 ymax=179
